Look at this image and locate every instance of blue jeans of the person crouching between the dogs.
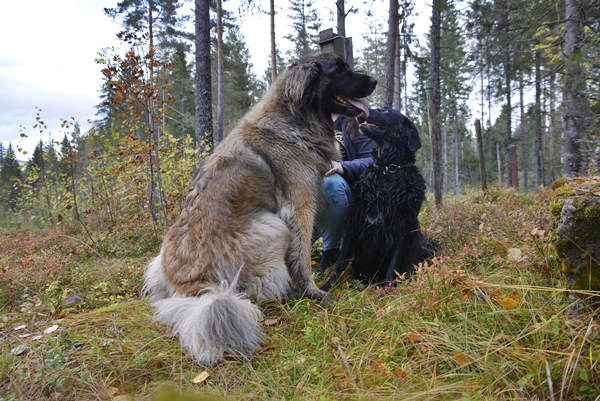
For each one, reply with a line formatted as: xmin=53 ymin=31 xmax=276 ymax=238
xmin=315 ymin=174 xmax=352 ymax=251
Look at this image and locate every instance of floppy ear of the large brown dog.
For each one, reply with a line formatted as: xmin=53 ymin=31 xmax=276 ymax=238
xmin=284 ymin=62 xmax=322 ymax=109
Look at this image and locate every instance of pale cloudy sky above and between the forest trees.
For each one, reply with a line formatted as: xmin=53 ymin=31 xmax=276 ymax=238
xmin=0 ymin=0 xmax=429 ymax=160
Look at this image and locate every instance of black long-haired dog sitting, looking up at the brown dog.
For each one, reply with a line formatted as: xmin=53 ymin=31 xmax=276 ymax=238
xmin=321 ymin=108 xmax=432 ymax=291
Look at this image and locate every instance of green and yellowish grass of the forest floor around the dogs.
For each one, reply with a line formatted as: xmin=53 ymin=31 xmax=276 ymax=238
xmin=0 ymin=186 xmax=600 ymax=401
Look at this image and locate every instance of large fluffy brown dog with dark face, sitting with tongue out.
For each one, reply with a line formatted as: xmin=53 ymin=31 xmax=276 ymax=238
xmin=144 ymin=53 xmax=377 ymax=364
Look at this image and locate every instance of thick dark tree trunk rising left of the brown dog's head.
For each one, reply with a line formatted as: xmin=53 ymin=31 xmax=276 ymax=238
xmin=195 ymin=0 xmax=213 ymax=154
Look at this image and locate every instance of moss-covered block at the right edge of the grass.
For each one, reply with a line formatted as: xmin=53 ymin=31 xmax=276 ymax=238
xmin=550 ymin=176 xmax=600 ymax=291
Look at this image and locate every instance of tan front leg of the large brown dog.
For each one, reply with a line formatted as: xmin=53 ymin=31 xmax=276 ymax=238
xmin=280 ymin=206 xmax=330 ymax=300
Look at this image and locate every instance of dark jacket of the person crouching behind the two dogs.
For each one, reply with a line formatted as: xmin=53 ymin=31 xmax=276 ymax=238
xmin=340 ymin=115 xmax=375 ymax=186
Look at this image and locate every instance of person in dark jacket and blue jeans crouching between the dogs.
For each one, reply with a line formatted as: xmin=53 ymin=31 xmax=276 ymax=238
xmin=315 ymin=117 xmax=375 ymax=274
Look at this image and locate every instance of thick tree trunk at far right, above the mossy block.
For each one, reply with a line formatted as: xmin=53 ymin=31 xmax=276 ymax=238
xmin=563 ymin=0 xmax=585 ymax=177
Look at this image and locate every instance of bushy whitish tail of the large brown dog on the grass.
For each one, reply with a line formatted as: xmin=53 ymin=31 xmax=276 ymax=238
xmin=152 ymin=283 xmax=262 ymax=364
